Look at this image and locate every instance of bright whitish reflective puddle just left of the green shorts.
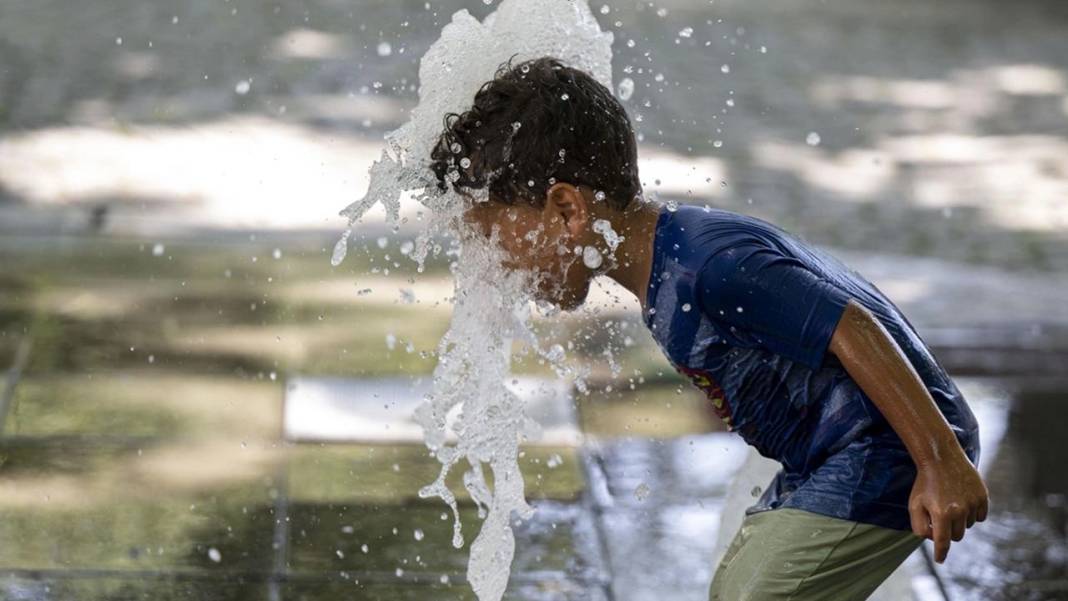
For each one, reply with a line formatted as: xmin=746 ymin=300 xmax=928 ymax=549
xmin=591 ymin=432 xmax=747 ymax=601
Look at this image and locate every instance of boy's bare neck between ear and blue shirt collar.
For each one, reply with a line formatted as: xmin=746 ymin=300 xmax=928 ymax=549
xmin=606 ymin=201 xmax=661 ymax=310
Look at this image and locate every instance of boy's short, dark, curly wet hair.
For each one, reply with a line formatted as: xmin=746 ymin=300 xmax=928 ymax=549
xmin=430 ymin=57 xmax=641 ymax=210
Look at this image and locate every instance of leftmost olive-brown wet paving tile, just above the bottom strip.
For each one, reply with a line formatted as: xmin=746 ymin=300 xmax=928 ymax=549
xmin=0 ymin=441 xmax=279 ymax=571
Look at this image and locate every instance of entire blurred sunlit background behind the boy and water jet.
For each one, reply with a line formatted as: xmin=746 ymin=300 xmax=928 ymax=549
xmin=0 ymin=0 xmax=1068 ymax=601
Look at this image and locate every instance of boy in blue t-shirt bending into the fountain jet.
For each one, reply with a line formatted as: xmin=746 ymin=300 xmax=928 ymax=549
xmin=431 ymin=58 xmax=987 ymax=601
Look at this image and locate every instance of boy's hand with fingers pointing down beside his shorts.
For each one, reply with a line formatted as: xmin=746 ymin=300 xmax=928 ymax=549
xmin=909 ymin=452 xmax=989 ymax=564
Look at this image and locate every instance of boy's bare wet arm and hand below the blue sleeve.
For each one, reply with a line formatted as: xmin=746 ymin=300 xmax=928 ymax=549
xmin=830 ymin=301 xmax=988 ymax=563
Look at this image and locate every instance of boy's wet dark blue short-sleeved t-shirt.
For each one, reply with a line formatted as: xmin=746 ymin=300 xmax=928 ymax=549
xmin=643 ymin=206 xmax=979 ymax=529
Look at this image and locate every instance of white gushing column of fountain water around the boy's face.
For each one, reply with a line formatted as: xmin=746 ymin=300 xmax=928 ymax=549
xmin=331 ymin=0 xmax=614 ymax=601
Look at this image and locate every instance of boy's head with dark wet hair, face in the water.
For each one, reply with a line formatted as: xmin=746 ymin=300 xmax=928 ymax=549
xmin=430 ymin=58 xmax=642 ymax=309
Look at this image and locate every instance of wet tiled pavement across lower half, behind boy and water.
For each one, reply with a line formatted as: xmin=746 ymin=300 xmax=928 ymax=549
xmin=0 ymin=231 xmax=1068 ymax=601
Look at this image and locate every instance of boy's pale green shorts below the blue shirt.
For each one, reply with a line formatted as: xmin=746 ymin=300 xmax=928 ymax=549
xmin=709 ymin=508 xmax=923 ymax=601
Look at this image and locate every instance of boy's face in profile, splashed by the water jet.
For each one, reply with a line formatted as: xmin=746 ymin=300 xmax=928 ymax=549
xmin=464 ymin=196 xmax=594 ymax=311
